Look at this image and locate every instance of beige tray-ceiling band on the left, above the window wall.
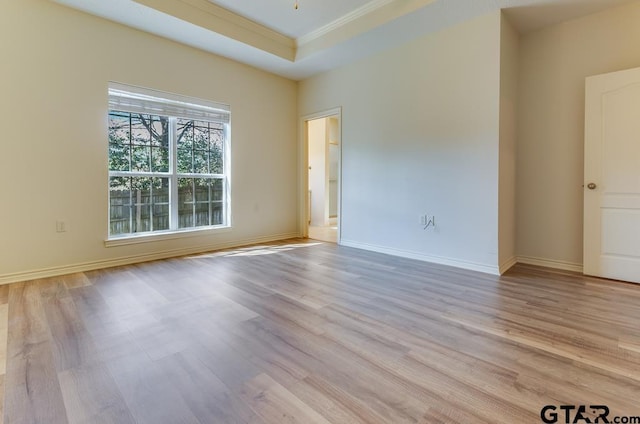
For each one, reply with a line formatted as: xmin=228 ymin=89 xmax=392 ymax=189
xmin=133 ymin=0 xmax=296 ymax=62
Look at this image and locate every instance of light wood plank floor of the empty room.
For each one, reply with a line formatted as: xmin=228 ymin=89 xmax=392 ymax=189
xmin=0 ymin=240 xmax=640 ymax=424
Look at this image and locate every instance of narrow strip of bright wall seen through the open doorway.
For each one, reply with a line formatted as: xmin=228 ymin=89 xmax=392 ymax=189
xmin=308 ymin=118 xmax=328 ymax=226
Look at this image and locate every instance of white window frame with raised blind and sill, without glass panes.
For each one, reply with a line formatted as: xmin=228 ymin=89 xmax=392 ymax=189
xmin=105 ymin=82 xmax=231 ymax=247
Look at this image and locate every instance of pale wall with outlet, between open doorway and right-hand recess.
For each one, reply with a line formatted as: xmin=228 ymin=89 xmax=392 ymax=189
xmin=299 ymin=12 xmax=501 ymax=272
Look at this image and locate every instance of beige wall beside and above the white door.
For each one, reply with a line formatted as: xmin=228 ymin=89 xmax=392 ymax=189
xmin=516 ymin=2 xmax=640 ymax=270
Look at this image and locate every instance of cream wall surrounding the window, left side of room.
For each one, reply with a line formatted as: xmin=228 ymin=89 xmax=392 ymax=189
xmin=0 ymin=0 xmax=298 ymax=282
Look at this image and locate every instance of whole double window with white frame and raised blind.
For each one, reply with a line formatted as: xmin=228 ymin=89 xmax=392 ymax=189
xmin=109 ymin=83 xmax=230 ymax=238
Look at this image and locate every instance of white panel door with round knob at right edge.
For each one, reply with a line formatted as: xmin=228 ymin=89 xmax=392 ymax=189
xmin=583 ymin=68 xmax=640 ymax=283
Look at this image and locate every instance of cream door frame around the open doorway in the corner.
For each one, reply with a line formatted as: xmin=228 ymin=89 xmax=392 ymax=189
xmin=298 ymin=107 xmax=342 ymax=244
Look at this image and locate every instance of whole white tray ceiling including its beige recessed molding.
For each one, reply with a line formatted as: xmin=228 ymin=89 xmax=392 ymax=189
xmin=52 ymin=0 xmax=630 ymax=80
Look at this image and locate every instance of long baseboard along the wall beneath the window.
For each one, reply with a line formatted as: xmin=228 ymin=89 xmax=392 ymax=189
xmin=0 ymin=232 xmax=300 ymax=285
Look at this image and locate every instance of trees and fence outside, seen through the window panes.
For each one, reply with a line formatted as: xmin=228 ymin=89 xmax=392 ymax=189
xmin=109 ymin=111 xmax=225 ymax=235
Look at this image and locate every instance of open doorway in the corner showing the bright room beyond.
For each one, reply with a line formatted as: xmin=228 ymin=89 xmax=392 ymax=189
xmin=304 ymin=111 xmax=342 ymax=243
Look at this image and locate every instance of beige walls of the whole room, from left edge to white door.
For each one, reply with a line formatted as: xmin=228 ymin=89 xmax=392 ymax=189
xmin=5 ymin=0 xmax=640 ymax=282
